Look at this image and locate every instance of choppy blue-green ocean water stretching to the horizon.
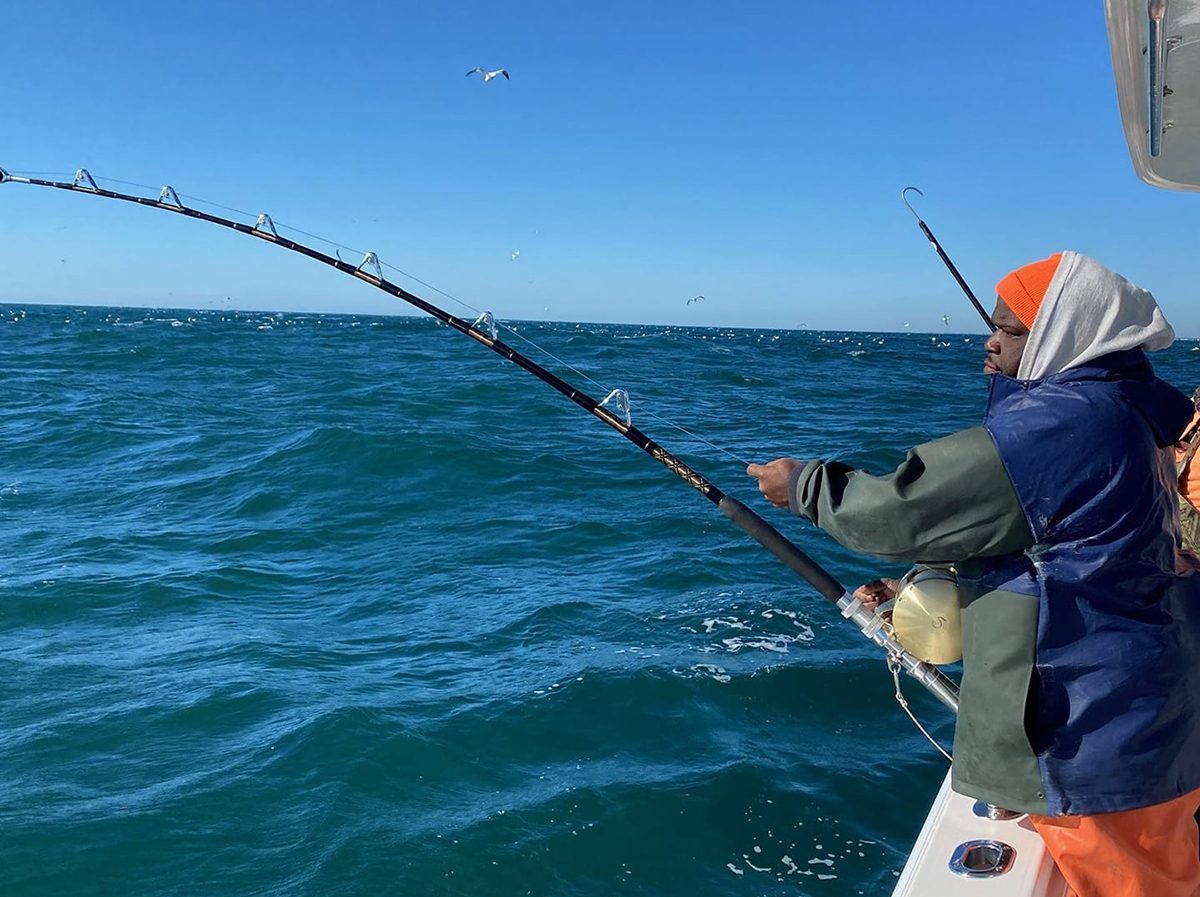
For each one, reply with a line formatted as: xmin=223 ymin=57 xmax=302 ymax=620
xmin=0 ymin=306 xmax=1200 ymax=897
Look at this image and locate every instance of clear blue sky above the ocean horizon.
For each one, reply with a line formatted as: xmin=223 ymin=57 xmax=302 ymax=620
xmin=0 ymin=0 xmax=1200 ymax=337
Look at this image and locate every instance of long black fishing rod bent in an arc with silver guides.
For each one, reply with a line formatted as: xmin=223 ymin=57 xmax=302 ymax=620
xmin=0 ymin=168 xmax=959 ymax=711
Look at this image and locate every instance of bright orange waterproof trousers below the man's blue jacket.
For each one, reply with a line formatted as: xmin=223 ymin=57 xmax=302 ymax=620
xmin=1030 ymin=789 xmax=1200 ymax=897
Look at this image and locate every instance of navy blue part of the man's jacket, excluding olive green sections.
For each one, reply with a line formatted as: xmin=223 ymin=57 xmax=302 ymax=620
xmin=984 ymin=349 xmax=1200 ymax=814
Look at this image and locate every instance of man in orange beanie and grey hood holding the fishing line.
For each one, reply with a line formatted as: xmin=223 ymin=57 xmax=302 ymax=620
xmin=746 ymin=252 xmax=1200 ymax=897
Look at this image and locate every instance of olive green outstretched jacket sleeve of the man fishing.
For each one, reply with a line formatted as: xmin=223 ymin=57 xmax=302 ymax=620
xmin=791 ymin=427 xmax=1033 ymax=562
